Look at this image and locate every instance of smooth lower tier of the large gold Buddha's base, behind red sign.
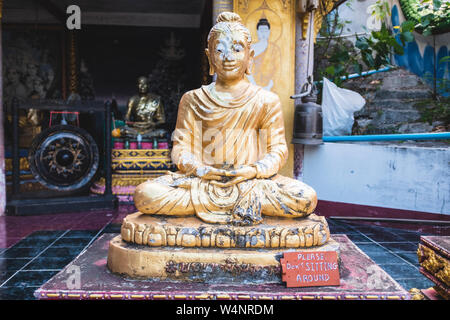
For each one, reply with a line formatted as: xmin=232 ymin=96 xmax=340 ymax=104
xmin=108 ymin=232 xmax=339 ymax=284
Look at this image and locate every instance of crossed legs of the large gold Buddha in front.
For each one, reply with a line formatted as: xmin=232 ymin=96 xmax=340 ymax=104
xmin=134 ymin=174 xmax=317 ymax=223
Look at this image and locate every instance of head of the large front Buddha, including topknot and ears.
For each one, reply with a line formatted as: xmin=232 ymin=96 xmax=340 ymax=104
xmin=205 ymin=12 xmax=254 ymax=81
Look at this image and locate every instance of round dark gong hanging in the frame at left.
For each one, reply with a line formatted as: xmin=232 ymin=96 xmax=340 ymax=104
xmin=28 ymin=125 xmax=99 ymax=191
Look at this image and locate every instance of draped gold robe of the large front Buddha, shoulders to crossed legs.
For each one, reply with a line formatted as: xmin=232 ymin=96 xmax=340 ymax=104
xmin=134 ymin=84 xmax=317 ymax=225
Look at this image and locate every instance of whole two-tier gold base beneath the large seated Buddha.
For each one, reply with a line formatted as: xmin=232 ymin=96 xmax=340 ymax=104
xmin=108 ymin=212 xmax=339 ymax=283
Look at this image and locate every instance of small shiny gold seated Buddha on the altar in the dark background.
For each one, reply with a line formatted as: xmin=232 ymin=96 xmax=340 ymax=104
xmin=120 ymin=77 xmax=166 ymax=138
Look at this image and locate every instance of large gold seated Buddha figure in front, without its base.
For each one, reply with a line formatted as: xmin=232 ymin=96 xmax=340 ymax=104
xmin=134 ymin=12 xmax=317 ymax=226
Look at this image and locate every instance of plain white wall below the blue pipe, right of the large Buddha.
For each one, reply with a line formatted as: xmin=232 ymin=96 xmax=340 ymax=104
xmin=303 ymin=143 xmax=450 ymax=214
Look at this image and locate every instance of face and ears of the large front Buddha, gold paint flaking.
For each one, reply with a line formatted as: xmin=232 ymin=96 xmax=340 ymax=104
xmin=206 ymin=29 xmax=253 ymax=81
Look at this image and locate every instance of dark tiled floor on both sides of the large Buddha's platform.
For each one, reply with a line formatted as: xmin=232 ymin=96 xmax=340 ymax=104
xmin=0 ymin=206 xmax=450 ymax=300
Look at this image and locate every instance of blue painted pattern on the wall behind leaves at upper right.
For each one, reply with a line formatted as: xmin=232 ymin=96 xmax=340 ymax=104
xmin=391 ymin=4 xmax=450 ymax=96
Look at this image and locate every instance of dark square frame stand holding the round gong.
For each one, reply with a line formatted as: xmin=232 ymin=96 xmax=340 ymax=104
xmin=6 ymin=100 xmax=117 ymax=215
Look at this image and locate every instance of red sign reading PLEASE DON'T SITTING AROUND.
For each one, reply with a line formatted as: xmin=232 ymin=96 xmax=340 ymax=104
xmin=280 ymin=251 xmax=340 ymax=287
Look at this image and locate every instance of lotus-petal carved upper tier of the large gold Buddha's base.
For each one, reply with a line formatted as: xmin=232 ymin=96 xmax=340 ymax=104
xmin=121 ymin=212 xmax=330 ymax=249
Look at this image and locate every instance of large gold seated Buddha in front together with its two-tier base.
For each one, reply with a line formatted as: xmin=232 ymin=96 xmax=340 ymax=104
xmin=108 ymin=12 xmax=339 ymax=282
